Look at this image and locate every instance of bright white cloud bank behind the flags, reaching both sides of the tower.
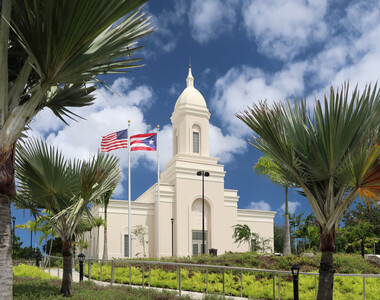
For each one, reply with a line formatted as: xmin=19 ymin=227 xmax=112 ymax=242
xmin=28 ymin=77 xmax=246 ymax=195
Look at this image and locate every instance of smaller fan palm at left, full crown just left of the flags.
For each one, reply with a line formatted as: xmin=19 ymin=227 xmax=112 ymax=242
xmin=16 ymin=139 xmax=120 ymax=295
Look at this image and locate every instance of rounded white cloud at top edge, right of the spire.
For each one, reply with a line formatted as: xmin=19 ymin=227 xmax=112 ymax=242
xmin=243 ymin=0 xmax=328 ymax=60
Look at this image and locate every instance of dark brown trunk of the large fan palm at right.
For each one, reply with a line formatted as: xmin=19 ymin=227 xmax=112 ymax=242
xmin=317 ymin=228 xmax=336 ymax=300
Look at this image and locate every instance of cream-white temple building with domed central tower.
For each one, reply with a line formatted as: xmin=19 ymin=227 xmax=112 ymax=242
xmin=85 ymin=67 xmax=275 ymax=258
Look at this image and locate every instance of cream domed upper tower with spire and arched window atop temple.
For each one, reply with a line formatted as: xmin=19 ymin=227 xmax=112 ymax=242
xmin=171 ymin=66 xmax=210 ymax=157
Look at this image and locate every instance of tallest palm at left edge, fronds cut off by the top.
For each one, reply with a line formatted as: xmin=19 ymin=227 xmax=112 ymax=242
xmin=0 ymin=0 xmax=152 ymax=299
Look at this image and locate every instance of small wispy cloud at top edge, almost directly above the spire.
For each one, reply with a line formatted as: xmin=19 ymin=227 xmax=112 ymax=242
xmin=189 ymin=0 xmax=238 ymax=43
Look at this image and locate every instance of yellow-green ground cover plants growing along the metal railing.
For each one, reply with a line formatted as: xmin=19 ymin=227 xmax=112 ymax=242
xmin=73 ymin=252 xmax=380 ymax=299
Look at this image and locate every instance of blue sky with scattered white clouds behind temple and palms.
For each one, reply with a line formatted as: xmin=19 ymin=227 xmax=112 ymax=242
xmin=13 ymin=0 xmax=380 ymax=245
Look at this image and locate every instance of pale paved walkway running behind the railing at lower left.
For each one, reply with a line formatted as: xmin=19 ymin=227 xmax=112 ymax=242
xmin=45 ymin=268 xmax=247 ymax=300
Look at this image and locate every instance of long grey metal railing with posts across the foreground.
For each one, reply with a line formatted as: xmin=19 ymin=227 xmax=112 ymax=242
xmin=41 ymin=256 xmax=380 ymax=300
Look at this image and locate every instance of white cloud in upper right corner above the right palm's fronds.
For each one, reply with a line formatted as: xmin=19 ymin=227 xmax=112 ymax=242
xmin=307 ymin=1 xmax=380 ymax=98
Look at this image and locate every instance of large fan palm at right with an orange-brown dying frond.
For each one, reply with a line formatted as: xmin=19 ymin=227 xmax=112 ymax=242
xmin=236 ymin=84 xmax=380 ymax=300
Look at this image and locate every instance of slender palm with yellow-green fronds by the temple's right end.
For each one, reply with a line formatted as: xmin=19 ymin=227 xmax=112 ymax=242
xmin=253 ymin=155 xmax=292 ymax=255
